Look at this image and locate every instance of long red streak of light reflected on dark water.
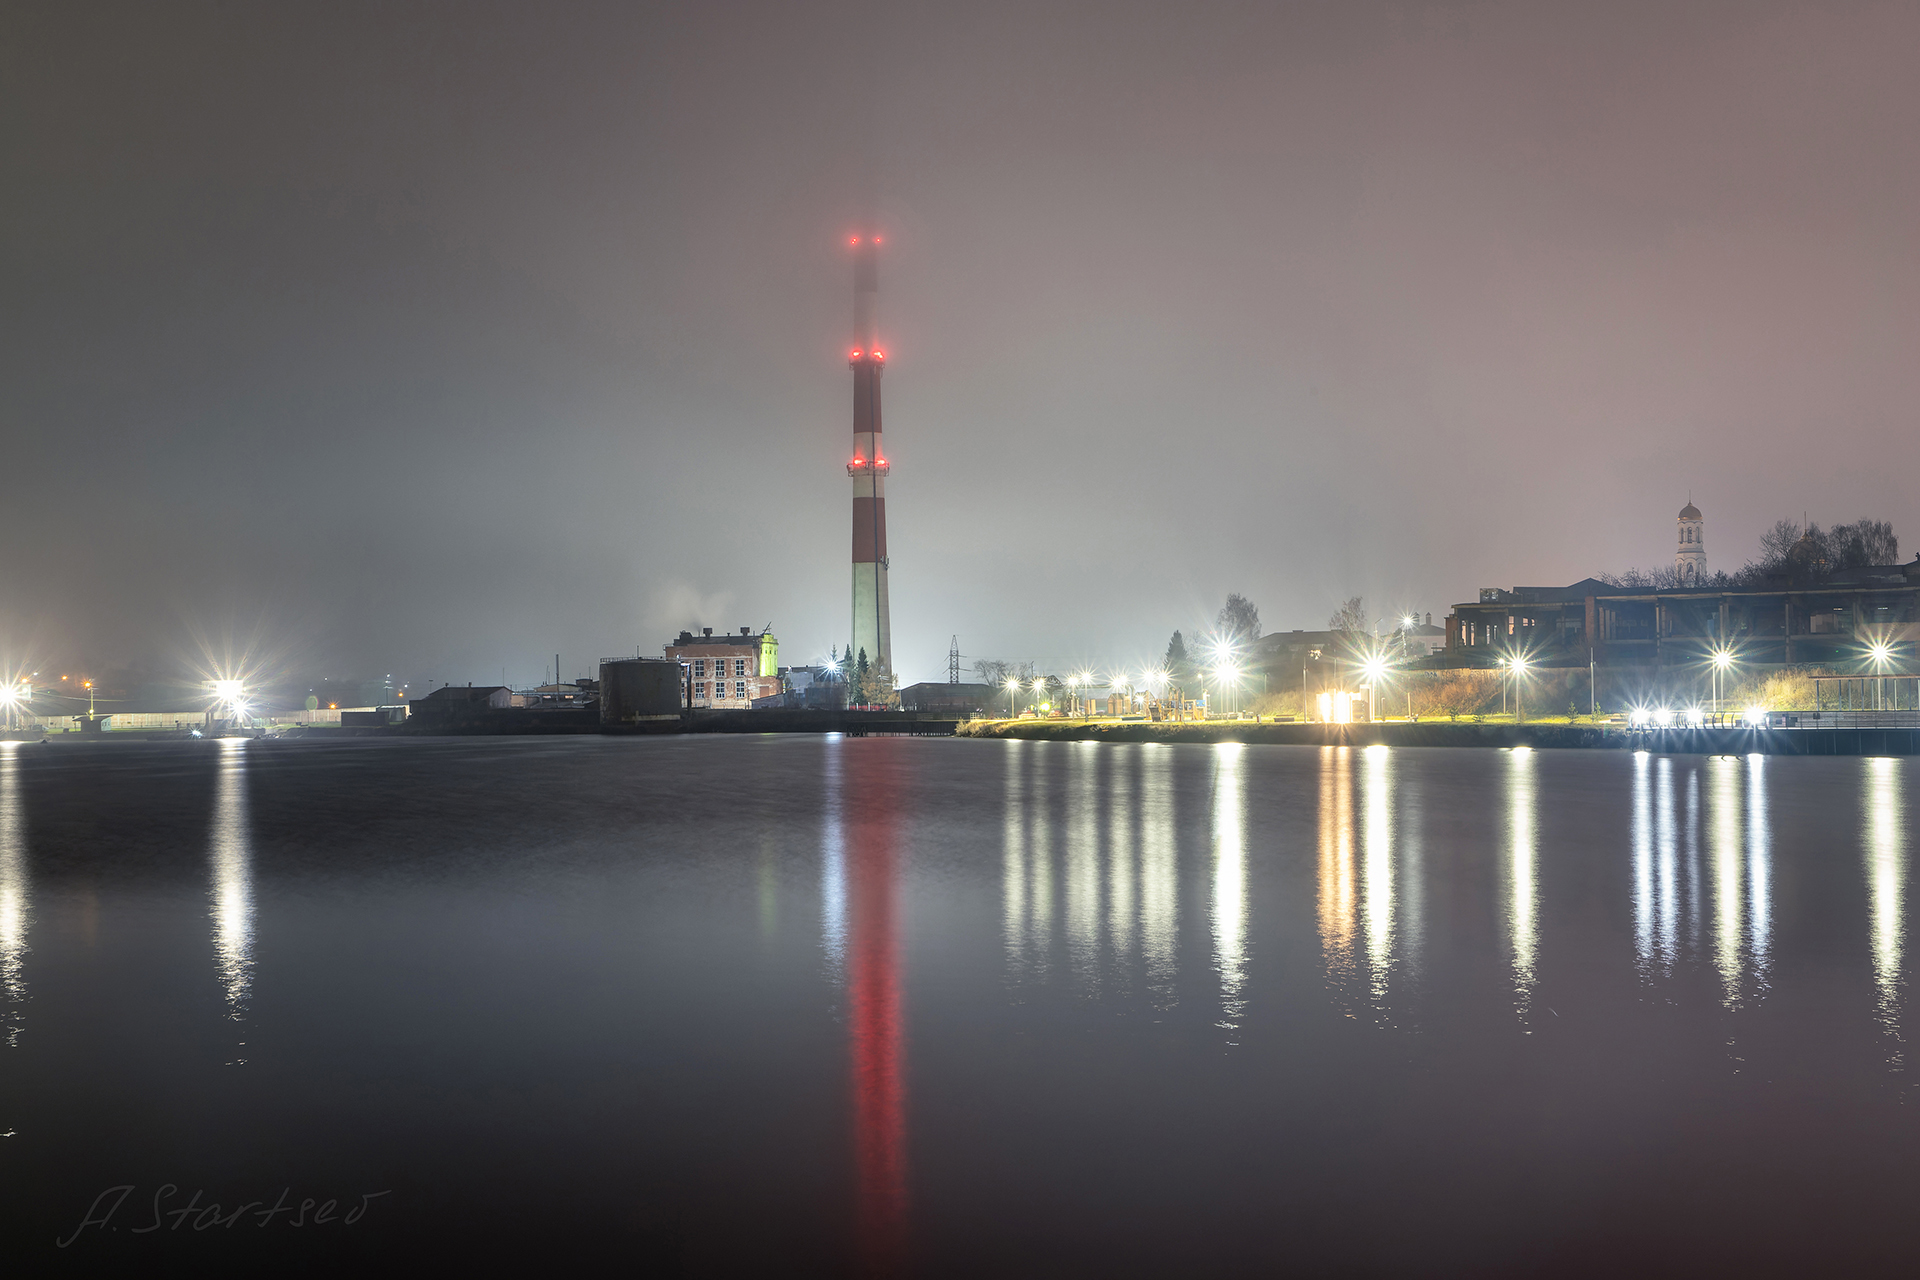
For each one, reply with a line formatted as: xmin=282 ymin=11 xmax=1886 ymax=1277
xmin=847 ymin=779 xmax=906 ymax=1274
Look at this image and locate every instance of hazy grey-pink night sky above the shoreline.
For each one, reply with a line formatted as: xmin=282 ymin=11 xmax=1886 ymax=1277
xmin=0 ymin=0 xmax=1920 ymax=683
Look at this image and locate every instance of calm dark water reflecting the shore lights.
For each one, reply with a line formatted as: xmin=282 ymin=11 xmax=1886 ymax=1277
xmin=0 ymin=737 xmax=1920 ymax=1276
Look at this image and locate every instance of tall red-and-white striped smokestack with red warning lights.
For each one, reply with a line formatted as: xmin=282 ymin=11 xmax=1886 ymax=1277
xmin=847 ymin=236 xmax=893 ymax=672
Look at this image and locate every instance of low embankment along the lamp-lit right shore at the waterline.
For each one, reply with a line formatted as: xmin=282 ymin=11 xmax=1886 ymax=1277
xmin=958 ymin=720 xmax=1920 ymax=756
